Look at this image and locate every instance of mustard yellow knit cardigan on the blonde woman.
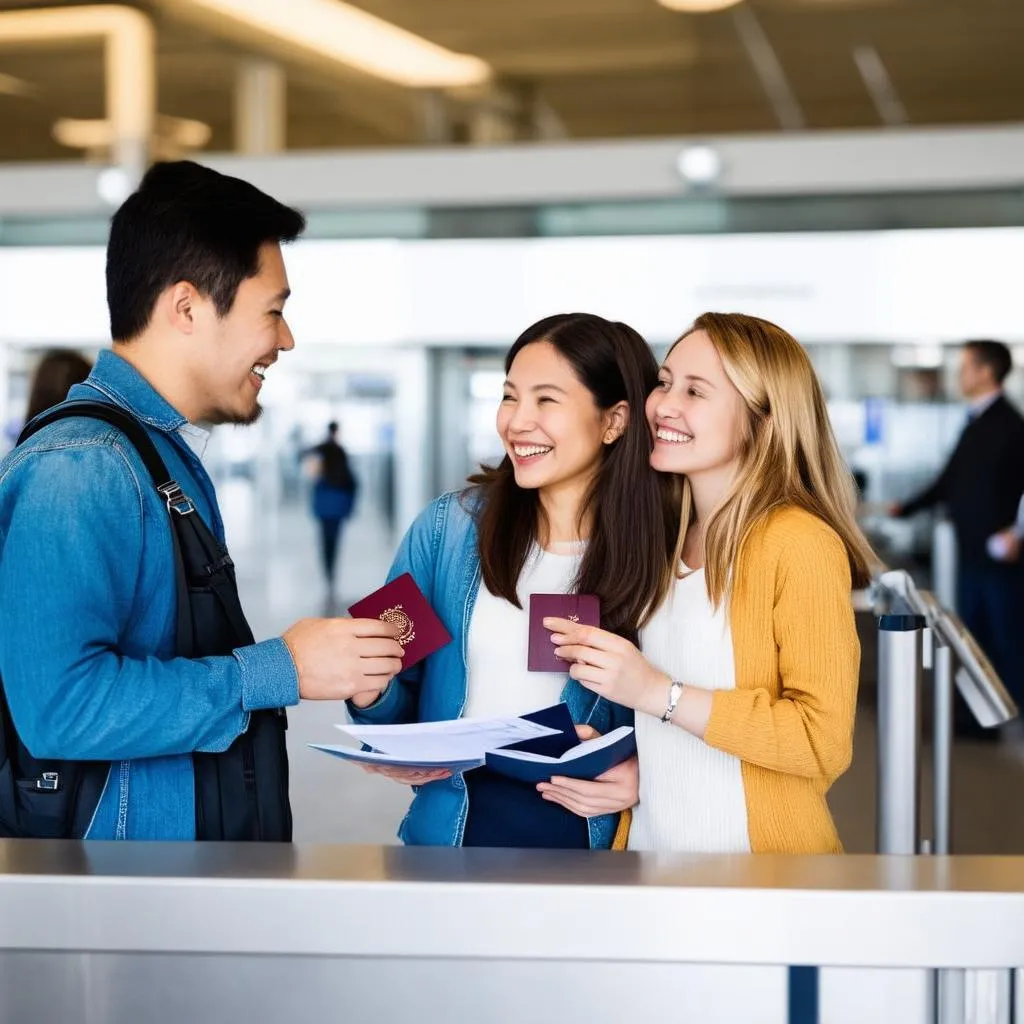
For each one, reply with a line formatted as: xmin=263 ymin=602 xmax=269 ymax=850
xmin=613 ymin=506 xmax=860 ymax=853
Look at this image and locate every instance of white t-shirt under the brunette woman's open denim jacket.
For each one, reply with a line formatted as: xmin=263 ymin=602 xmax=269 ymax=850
xmin=463 ymin=542 xmax=585 ymax=718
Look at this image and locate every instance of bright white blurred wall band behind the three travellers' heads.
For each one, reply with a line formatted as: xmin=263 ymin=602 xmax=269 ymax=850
xmin=0 ymin=228 xmax=1024 ymax=346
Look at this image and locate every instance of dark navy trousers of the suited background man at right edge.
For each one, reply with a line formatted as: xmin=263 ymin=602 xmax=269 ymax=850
xmin=956 ymin=562 xmax=1024 ymax=716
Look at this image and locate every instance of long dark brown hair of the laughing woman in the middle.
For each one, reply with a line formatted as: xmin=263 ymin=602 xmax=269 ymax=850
xmin=469 ymin=313 xmax=679 ymax=642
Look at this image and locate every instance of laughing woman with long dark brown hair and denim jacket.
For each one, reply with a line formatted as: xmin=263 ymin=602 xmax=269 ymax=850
xmin=349 ymin=313 xmax=674 ymax=848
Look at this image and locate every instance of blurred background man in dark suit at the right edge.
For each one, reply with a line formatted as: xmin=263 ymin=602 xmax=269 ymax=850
xmin=892 ymin=341 xmax=1024 ymax=720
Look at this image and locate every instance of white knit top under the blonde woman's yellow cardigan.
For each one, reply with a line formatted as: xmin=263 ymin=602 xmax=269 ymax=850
xmin=629 ymin=569 xmax=751 ymax=853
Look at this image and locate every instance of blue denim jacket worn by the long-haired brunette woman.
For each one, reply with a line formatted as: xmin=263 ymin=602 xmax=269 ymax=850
xmin=348 ymin=493 xmax=633 ymax=850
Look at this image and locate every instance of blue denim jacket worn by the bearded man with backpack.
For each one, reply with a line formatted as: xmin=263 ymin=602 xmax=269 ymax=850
xmin=0 ymin=351 xmax=298 ymax=840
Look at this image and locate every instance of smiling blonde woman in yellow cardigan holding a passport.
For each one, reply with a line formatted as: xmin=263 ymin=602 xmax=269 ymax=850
xmin=545 ymin=313 xmax=873 ymax=853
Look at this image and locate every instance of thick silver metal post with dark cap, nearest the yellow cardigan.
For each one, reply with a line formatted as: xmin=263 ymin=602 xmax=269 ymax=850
xmin=878 ymin=614 xmax=927 ymax=855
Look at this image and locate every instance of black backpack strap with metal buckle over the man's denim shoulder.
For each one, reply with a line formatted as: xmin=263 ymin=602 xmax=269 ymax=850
xmin=17 ymin=401 xmax=196 ymax=653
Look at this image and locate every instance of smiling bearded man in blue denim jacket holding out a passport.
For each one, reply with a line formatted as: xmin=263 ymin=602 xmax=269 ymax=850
xmin=0 ymin=162 xmax=401 ymax=840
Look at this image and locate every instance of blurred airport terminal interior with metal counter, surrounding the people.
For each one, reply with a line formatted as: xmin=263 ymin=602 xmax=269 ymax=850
xmin=0 ymin=0 xmax=1024 ymax=1024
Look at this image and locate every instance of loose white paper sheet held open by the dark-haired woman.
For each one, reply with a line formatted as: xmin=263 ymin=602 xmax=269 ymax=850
xmin=310 ymin=717 xmax=558 ymax=771
